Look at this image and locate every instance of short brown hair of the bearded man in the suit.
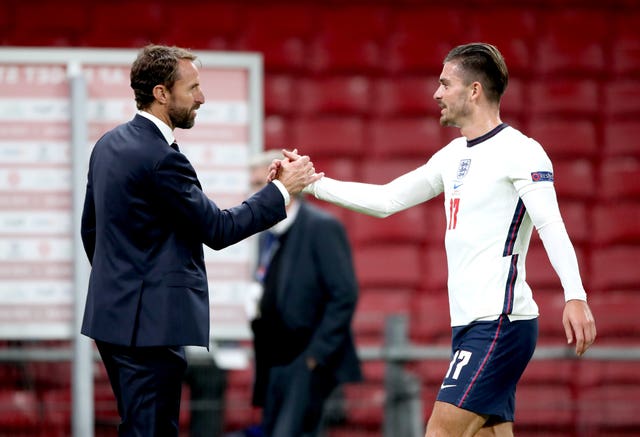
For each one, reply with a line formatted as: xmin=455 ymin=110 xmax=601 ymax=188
xmin=130 ymin=44 xmax=197 ymax=109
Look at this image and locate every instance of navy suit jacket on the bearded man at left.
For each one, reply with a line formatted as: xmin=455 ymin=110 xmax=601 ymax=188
xmin=81 ymin=115 xmax=286 ymax=346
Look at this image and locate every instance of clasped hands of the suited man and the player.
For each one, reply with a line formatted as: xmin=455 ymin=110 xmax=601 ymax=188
xmin=267 ymin=149 xmax=324 ymax=194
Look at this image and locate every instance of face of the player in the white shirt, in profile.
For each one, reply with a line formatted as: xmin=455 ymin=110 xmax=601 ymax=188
xmin=433 ymin=62 xmax=472 ymax=127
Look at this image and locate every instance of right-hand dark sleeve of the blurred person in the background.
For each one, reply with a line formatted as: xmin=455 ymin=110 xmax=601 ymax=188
xmin=306 ymin=219 xmax=358 ymax=365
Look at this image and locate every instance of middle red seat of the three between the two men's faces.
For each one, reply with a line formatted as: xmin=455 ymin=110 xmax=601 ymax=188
xmin=296 ymin=76 xmax=371 ymax=115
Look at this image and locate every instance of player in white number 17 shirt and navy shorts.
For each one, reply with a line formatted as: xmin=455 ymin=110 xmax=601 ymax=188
xmin=280 ymin=43 xmax=596 ymax=437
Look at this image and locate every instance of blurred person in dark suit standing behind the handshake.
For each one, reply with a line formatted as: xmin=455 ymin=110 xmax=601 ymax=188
xmin=251 ymin=151 xmax=362 ymax=437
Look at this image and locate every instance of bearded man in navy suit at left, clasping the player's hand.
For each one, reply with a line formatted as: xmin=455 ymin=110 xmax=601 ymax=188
xmin=81 ymin=45 xmax=317 ymax=437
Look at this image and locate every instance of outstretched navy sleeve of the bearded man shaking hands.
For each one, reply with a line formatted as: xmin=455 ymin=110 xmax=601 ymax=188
xmin=155 ymin=153 xmax=286 ymax=250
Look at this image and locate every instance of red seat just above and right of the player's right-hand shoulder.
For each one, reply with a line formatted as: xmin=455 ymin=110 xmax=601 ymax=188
xmin=527 ymin=118 xmax=599 ymax=161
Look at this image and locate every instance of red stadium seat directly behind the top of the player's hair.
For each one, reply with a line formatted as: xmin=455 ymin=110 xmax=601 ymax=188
xmin=468 ymin=8 xmax=538 ymax=74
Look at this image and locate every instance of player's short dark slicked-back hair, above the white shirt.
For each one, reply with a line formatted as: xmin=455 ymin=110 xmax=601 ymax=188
xmin=444 ymin=42 xmax=509 ymax=102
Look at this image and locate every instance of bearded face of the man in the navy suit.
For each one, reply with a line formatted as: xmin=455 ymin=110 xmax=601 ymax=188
xmin=167 ymin=59 xmax=204 ymax=129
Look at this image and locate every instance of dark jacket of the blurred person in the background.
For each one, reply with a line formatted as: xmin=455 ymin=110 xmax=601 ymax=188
xmin=252 ymin=202 xmax=362 ymax=405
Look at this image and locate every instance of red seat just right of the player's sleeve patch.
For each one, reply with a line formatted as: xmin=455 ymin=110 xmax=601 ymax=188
xmin=553 ymin=159 xmax=597 ymax=199
